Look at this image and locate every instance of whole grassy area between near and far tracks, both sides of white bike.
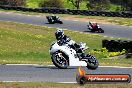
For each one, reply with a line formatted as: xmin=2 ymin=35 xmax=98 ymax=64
xmin=0 ymin=21 xmax=132 ymax=66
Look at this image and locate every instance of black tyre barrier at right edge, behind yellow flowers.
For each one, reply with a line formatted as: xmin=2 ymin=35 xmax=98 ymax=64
xmin=102 ymin=40 xmax=132 ymax=58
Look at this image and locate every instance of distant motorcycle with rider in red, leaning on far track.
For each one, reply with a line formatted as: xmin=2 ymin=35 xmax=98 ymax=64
xmin=87 ymin=23 xmax=104 ymax=33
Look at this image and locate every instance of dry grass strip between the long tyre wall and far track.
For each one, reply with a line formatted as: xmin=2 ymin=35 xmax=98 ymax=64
xmin=0 ymin=10 xmax=132 ymax=26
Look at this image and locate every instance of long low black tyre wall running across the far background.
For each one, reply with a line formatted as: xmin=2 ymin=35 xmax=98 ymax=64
xmin=0 ymin=6 xmax=132 ymax=18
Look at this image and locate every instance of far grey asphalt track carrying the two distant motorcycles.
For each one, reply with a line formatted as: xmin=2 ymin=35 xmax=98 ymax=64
xmin=0 ymin=12 xmax=132 ymax=39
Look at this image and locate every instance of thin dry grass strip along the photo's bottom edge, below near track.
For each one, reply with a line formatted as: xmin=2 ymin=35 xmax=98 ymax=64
xmin=0 ymin=82 xmax=132 ymax=88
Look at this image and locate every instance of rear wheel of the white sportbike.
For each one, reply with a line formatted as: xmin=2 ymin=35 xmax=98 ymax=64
xmin=87 ymin=55 xmax=99 ymax=70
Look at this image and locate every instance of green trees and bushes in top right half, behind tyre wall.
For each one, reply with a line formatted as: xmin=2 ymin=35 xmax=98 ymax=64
xmin=68 ymin=0 xmax=132 ymax=11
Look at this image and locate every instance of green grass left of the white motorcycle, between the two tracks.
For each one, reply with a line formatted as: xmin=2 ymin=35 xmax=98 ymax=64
xmin=0 ymin=22 xmax=54 ymax=62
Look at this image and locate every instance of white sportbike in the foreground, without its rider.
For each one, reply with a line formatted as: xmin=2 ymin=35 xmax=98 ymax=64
xmin=49 ymin=40 xmax=99 ymax=69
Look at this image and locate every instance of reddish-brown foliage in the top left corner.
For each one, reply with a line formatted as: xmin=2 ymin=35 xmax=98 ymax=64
xmin=0 ymin=0 xmax=26 ymax=6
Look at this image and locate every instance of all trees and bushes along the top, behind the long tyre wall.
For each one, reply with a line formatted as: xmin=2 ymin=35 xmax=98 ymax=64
xmin=0 ymin=0 xmax=132 ymax=11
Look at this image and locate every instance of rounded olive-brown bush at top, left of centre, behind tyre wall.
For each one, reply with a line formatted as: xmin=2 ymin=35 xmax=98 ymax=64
xmin=39 ymin=0 xmax=63 ymax=8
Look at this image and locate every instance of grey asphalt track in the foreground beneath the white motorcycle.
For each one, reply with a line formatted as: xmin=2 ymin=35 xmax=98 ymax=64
xmin=0 ymin=65 xmax=132 ymax=83
